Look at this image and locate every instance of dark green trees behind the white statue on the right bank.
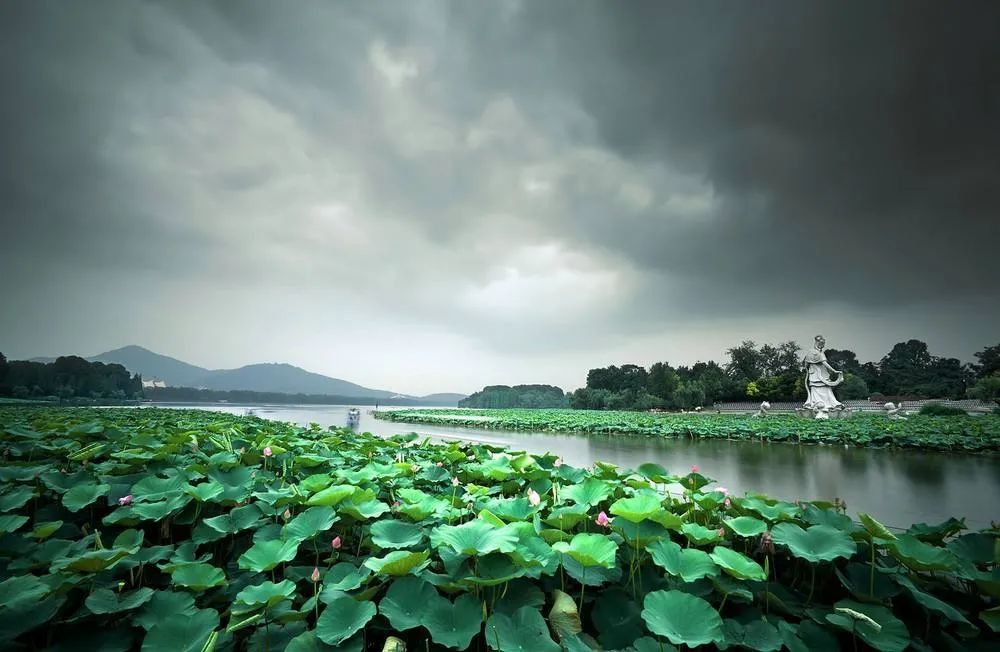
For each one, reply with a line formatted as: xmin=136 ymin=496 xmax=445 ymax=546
xmin=569 ymin=340 xmax=1000 ymax=410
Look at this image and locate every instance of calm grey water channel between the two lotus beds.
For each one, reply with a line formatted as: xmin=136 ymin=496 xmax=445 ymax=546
xmin=148 ymin=404 xmax=1000 ymax=527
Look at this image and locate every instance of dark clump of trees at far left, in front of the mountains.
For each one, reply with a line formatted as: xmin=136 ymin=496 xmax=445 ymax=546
xmin=0 ymin=353 xmax=142 ymax=400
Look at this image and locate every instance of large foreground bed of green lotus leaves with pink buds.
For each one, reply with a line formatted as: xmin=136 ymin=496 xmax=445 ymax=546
xmin=0 ymin=407 xmax=1000 ymax=652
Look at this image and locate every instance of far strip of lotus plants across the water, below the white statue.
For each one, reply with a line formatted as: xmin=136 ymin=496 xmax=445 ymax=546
xmin=377 ymin=410 xmax=1000 ymax=452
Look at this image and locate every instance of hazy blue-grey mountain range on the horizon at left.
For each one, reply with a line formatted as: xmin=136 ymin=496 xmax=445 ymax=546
xmin=33 ymin=345 xmax=465 ymax=403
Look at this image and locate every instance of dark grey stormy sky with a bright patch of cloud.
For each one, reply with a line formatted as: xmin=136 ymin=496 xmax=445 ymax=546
xmin=0 ymin=0 xmax=1000 ymax=394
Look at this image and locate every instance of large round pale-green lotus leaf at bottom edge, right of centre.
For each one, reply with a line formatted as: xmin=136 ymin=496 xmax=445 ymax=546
xmin=642 ymin=591 xmax=725 ymax=647
